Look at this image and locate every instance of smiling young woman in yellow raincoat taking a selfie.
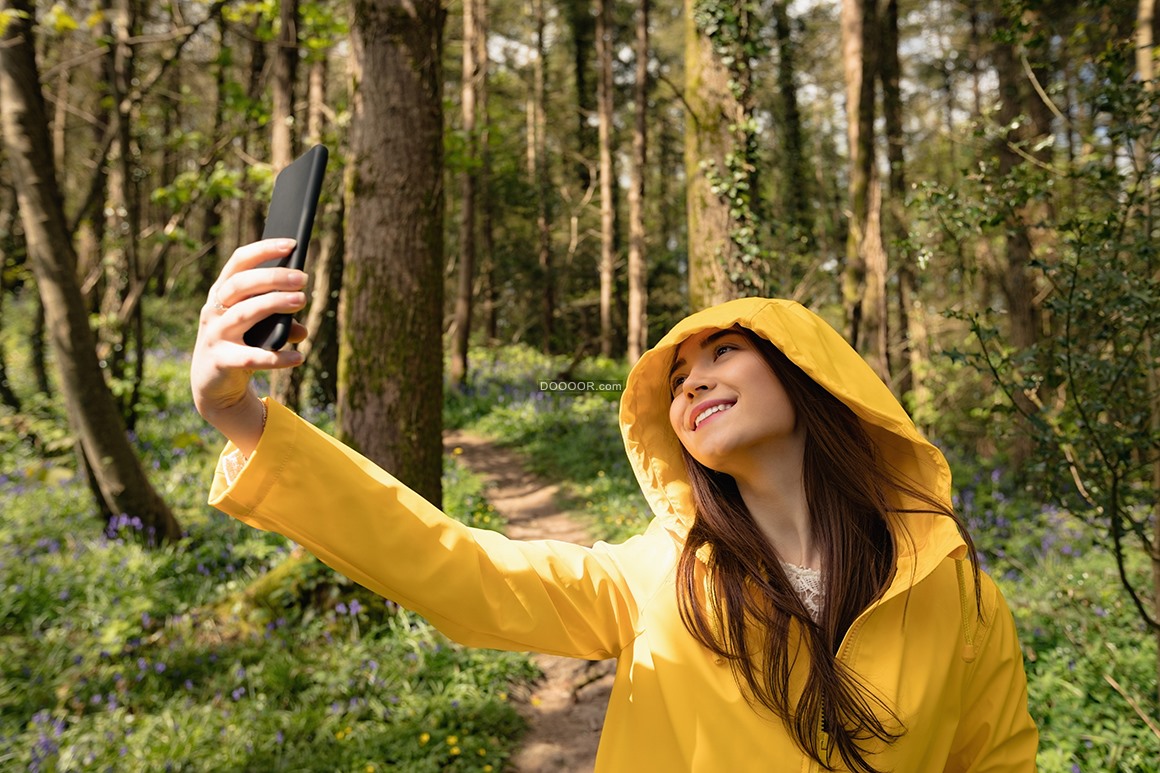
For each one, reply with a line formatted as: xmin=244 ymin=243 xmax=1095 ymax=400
xmin=191 ymin=241 xmax=1037 ymax=773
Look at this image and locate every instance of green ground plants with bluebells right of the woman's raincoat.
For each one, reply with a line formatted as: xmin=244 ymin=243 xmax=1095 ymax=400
xmin=955 ymin=464 xmax=1160 ymax=773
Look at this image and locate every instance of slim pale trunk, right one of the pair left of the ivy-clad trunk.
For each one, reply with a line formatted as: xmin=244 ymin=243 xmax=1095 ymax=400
xmin=628 ymin=0 xmax=648 ymax=366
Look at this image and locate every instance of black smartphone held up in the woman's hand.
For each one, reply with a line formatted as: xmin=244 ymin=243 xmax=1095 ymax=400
xmin=242 ymin=145 xmax=329 ymax=352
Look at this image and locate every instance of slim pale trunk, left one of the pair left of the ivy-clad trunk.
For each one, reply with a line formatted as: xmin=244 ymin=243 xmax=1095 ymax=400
xmin=596 ymin=0 xmax=616 ymax=357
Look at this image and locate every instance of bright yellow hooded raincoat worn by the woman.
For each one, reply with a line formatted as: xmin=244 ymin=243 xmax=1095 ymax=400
xmin=210 ymin=298 xmax=1037 ymax=773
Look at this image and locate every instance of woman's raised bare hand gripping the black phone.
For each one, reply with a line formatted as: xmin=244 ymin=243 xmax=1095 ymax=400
xmin=189 ymin=239 xmax=306 ymax=456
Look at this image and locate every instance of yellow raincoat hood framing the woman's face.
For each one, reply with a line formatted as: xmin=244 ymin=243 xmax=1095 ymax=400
xmin=621 ymin=298 xmax=965 ymax=571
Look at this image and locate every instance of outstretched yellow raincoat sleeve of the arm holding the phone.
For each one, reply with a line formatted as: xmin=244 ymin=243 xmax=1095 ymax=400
xmin=210 ymin=400 xmax=655 ymax=659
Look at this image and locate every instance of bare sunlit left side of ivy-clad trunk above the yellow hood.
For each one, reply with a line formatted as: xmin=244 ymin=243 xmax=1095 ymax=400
xmin=684 ymin=0 xmax=741 ymax=310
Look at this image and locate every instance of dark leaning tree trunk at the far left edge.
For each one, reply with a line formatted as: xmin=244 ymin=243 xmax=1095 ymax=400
xmin=0 ymin=0 xmax=181 ymax=542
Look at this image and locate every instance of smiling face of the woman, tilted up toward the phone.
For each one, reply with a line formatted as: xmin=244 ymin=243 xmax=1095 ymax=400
xmin=668 ymin=328 xmax=802 ymax=475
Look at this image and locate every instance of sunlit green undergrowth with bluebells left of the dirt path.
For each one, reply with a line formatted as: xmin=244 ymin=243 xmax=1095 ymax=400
xmin=0 ymin=301 xmax=536 ymax=772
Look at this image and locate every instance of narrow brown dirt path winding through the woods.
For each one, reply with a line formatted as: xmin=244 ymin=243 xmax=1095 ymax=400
xmin=443 ymin=432 xmax=616 ymax=773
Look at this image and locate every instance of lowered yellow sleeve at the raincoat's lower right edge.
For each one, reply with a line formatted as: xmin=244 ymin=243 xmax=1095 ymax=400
xmin=947 ymin=576 xmax=1039 ymax=773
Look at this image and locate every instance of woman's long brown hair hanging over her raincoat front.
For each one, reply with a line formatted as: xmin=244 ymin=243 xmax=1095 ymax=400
xmin=677 ymin=328 xmax=978 ymax=773
